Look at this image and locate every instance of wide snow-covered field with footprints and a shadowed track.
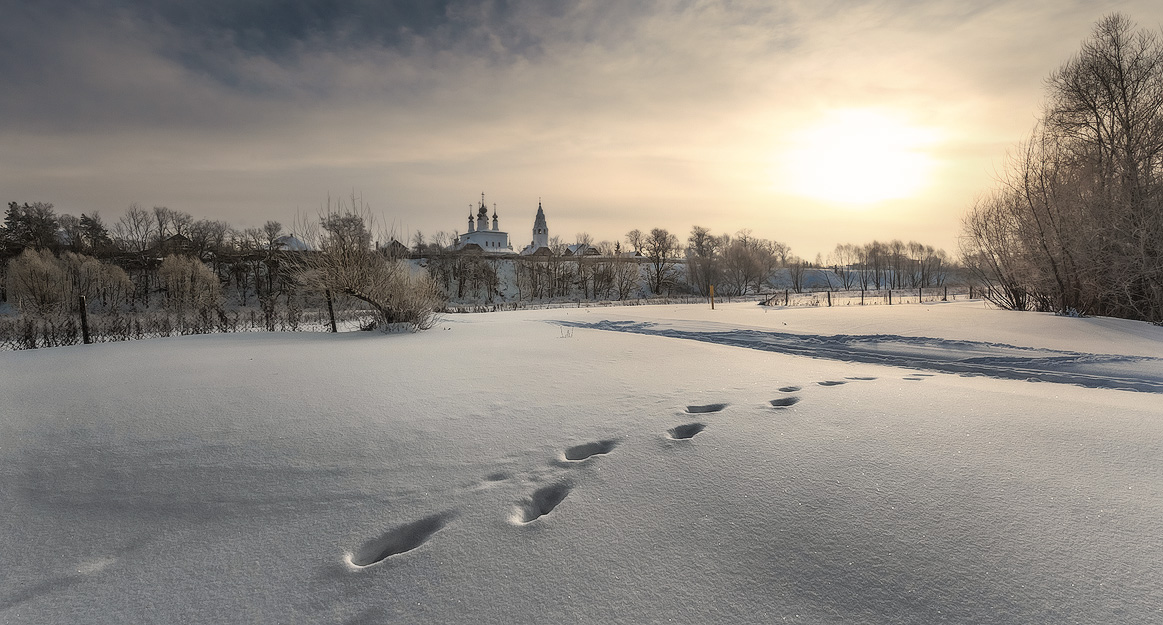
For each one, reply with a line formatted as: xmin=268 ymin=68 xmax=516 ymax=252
xmin=0 ymin=301 xmax=1163 ymax=625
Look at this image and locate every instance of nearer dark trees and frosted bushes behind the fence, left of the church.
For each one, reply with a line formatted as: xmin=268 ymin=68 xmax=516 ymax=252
xmin=0 ymin=194 xmax=441 ymax=347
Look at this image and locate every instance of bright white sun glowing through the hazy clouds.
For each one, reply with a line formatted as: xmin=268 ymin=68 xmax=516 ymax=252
xmin=780 ymin=109 xmax=935 ymax=206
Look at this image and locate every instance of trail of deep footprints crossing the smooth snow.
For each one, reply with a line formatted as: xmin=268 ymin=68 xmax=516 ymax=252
xmin=349 ymin=374 xmax=897 ymax=569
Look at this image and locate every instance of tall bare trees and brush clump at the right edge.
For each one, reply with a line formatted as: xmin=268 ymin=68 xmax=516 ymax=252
xmin=962 ymin=14 xmax=1163 ymax=322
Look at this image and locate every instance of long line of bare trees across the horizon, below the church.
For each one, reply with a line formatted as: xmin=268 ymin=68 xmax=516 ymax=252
xmin=0 ymin=194 xmax=951 ymax=346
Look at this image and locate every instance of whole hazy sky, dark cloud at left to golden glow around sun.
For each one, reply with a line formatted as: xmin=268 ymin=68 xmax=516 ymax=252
xmin=0 ymin=0 xmax=1163 ymax=258
